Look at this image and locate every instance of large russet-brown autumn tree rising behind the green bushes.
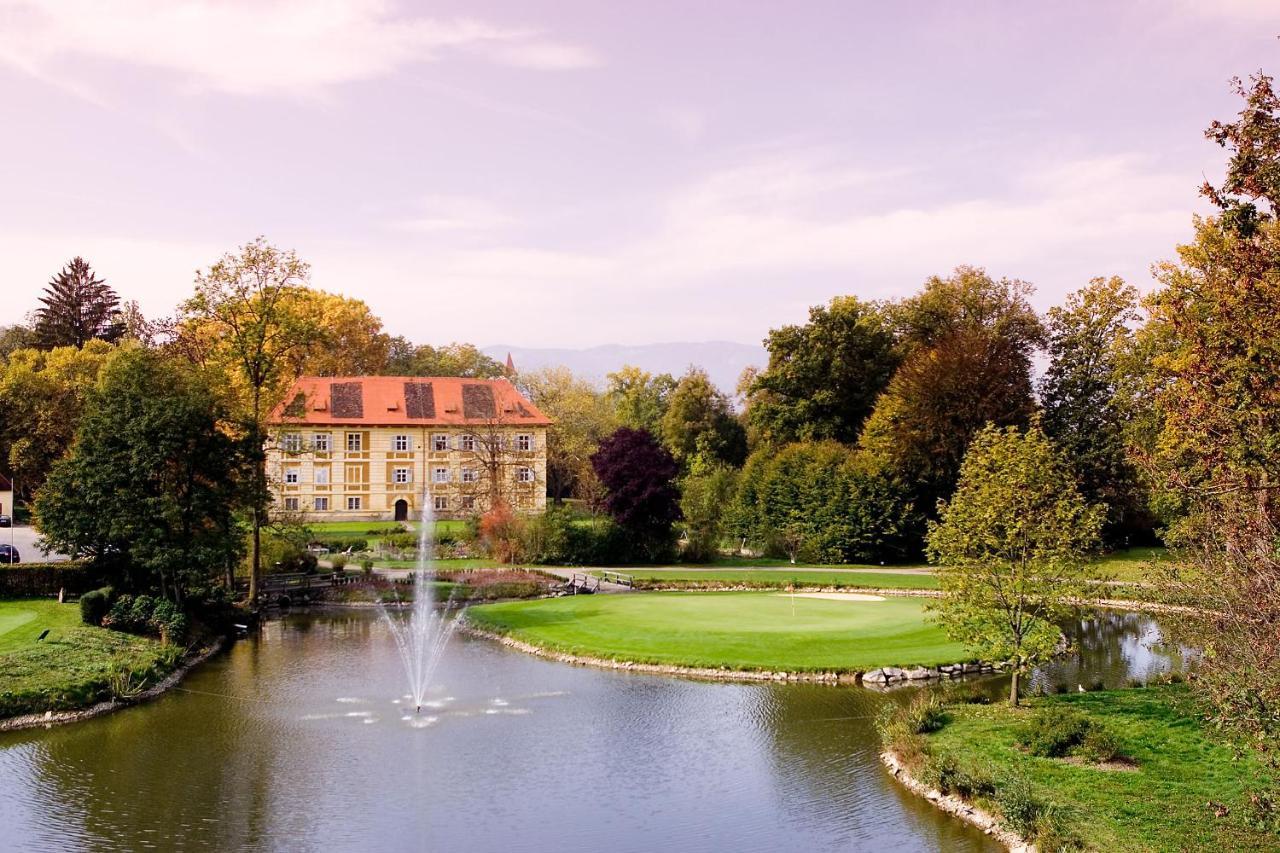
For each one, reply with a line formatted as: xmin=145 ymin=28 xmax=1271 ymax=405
xmin=859 ymin=266 xmax=1043 ymax=514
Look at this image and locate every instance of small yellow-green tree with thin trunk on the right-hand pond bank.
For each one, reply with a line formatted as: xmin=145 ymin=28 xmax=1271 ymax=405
xmin=928 ymin=425 xmax=1103 ymax=706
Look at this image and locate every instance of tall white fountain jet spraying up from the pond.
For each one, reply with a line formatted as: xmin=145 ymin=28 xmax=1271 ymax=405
xmin=381 ymin=487 xmax=457 ymax=713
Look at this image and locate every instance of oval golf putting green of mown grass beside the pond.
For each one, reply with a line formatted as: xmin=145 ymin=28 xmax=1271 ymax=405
xmin=468 ymin=593 xmax=969 ymax=671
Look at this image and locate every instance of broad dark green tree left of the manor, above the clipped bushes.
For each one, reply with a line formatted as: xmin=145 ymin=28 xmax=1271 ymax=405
xmin=36 ymin=348 xmax=242 ymax=603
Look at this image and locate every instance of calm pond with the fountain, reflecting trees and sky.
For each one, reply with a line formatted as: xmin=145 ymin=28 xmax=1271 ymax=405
xmin=0 ymin=611 xmax=1181 ymax=853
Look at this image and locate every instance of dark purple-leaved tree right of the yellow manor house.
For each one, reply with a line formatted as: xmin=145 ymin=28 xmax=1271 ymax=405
xmin=591 ymin=427 xmax=680 ymax=560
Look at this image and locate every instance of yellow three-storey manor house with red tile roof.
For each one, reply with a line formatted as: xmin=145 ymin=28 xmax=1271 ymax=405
xmin=266 ymin=377 xmax=552 ymax=521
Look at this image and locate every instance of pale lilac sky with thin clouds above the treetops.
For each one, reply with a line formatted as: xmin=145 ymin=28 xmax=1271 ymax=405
xmin=0 ymin=0 xmax=1280 ymax=347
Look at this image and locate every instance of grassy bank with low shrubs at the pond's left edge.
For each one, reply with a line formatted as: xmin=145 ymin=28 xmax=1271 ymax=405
xmin=0 ymin=599 xmax=182 ymax=717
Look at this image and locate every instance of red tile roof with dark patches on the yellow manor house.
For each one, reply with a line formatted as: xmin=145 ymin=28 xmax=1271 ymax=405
xmin=270 ymin=377 xmax=552 ymax=427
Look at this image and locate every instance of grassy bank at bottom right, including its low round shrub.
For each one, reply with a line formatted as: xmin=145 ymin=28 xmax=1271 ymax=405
xmin=899 ymin=685 xmax=1280 ymax=850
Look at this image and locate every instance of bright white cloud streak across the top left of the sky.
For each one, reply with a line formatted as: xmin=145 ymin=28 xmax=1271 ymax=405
xmin=0 ymin=0 xmax=598 ymax=95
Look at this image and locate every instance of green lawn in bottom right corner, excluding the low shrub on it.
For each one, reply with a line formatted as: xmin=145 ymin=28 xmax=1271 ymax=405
xmin=927 ymin=685 xmax=1280 ymax=850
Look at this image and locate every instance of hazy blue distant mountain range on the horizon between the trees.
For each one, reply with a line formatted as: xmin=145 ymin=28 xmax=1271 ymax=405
xmin=483 ymin=341 xmax=769 ymax=396
